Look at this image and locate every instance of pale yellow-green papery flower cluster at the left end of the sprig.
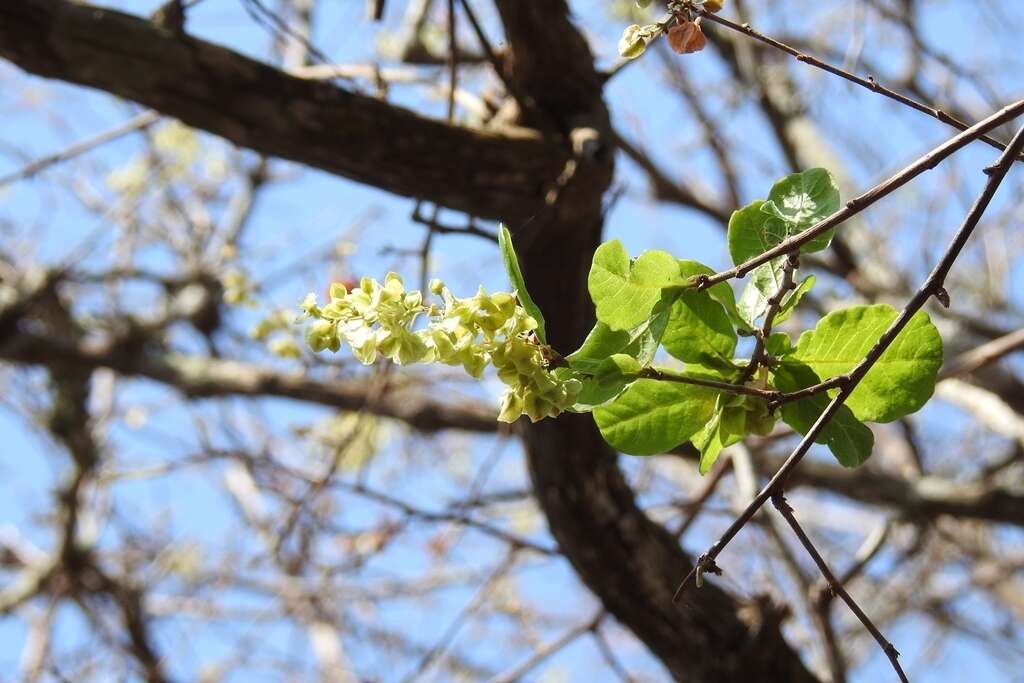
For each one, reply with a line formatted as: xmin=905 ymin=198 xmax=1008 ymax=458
xmin=302 ymin=272 xmax=581 ymax=422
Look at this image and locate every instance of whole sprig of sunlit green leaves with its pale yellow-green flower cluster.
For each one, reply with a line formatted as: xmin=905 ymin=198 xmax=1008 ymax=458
xmin=303 ymin=169 xmax=942 ymax=473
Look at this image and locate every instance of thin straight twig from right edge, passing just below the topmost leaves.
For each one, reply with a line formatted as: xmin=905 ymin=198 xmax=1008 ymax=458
xmin=694 ymin=99 xmax=1024 ymax=289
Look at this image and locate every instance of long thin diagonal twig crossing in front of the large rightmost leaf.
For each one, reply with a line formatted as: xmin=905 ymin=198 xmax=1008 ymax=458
xmin=673 ymin=120 xmax=1024 ymax=602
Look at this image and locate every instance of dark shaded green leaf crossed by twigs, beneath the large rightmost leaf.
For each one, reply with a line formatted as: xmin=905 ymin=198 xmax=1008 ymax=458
xmin=774 ymin=362 xmax=874 ymax=467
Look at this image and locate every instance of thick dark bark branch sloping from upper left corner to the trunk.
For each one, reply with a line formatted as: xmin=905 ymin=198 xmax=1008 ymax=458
xmin=0 ymin=0 xmax=566 ymax=221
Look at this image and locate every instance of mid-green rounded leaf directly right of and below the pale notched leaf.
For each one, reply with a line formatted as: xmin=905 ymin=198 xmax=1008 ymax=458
xmin=662 ymin=290 xmax=736 ymax=368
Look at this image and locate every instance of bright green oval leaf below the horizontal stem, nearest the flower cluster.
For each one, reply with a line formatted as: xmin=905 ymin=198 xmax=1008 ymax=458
xmin=594 ymin=380 xmax=718 ymax=456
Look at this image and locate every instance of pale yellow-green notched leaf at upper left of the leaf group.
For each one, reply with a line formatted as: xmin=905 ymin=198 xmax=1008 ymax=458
xmin=587 ymin=240 xmax=685 ymax=330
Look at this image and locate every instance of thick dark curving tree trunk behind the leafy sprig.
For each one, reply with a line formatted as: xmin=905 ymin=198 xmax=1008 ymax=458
xmin=498 ymin=0 xmax=816 ymax=683
